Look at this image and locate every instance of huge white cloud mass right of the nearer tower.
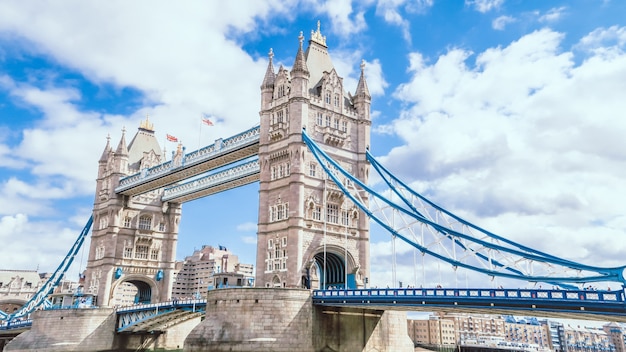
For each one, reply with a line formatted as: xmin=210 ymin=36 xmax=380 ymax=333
xmin=372 ymin=30 xmax=626 ymax=276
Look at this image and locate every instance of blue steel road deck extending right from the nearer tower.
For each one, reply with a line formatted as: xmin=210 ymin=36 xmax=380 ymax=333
xmin=312 ymin=288 xmax=626 ymax=321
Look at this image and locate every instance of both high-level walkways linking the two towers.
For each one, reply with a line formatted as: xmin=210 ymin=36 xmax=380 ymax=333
xmin=115 ymin=126 xmax=261 ymax=202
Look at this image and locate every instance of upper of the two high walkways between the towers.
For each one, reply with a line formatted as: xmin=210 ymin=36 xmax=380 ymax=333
xmin=115 ymin=126 xmax=261 ymax=193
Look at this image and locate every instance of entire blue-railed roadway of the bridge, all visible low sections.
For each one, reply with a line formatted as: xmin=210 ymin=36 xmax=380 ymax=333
xmin=0 ymin=288 xmax=626 ymax=336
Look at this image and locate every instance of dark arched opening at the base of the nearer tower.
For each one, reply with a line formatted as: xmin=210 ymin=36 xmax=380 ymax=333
xmin=303 ymin=251 xmax=350 ymax=290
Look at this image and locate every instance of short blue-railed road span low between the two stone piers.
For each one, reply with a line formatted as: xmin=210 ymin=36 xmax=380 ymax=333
xmin=116 ymin=299 xmax=206 ymax=333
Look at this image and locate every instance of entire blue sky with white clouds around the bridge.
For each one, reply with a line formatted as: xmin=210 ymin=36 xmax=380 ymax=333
xmin=0 ymin=0 xmax=626 ymax=286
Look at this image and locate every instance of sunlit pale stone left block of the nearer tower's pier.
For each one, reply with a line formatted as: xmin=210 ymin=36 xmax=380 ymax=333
xmin=184 ymin=288 xmax=313 ymax=352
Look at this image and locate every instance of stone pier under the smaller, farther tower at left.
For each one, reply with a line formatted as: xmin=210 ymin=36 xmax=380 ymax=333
xmin=4 ymin=308 xmax=115 ymax=352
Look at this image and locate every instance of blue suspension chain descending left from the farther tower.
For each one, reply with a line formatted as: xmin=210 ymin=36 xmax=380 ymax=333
xmin=0 ymin=215 xmax=93 ymax=322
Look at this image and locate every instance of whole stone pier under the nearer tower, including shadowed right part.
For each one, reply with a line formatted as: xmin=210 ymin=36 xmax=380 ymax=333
xmin=184 ymin=288 xmax=413 ymax=352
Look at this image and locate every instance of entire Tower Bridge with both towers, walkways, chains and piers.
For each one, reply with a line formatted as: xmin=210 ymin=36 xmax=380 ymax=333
xmin=0 ymin=22 xmax=626 ymax=350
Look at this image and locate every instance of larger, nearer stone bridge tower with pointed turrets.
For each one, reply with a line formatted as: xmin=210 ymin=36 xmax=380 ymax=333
xmin=256 ymin=22 xmax=371 ymax=288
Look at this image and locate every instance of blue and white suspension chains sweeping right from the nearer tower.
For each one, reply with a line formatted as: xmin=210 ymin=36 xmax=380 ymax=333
xmin=302 ymin=131 xmax=626 ymax=287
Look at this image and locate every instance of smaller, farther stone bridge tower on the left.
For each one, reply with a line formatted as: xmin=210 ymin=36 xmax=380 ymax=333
xmin=85 ymin=118 xmax=181 ymax=306
